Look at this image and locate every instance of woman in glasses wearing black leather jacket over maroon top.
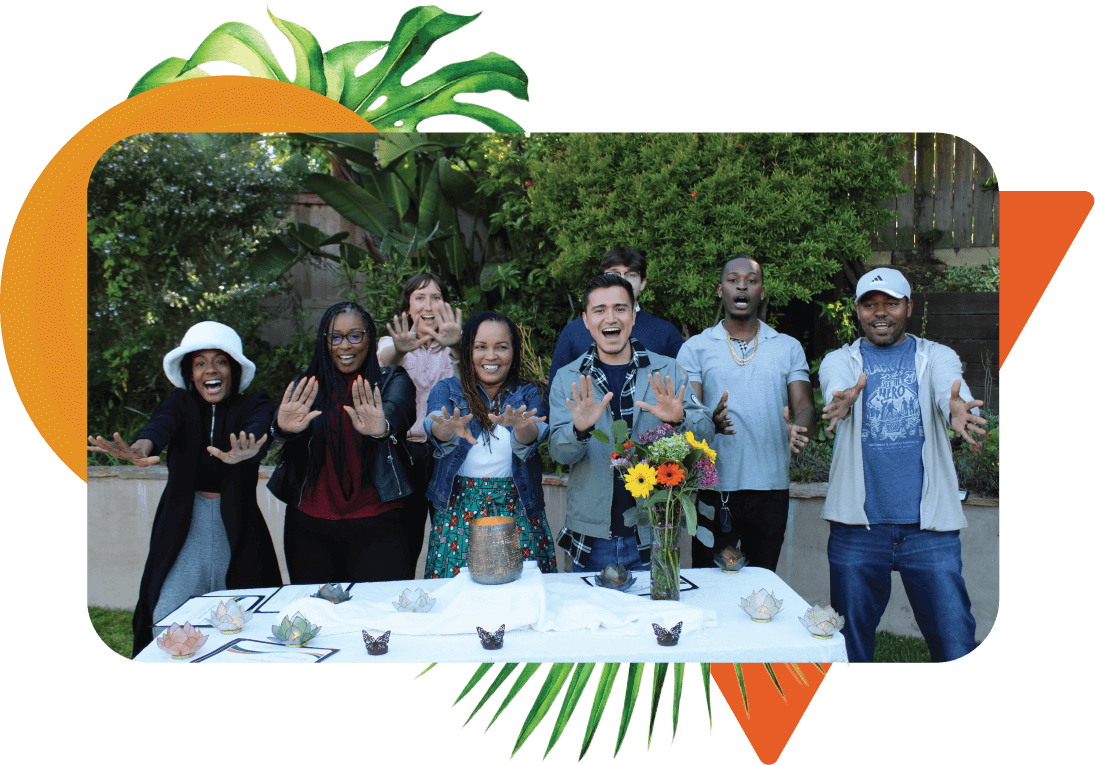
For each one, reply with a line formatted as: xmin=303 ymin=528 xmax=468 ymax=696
xmin=267 ymin=302 xmax=415 ymax=583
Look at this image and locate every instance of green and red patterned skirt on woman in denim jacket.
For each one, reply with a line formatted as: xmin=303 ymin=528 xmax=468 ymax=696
xmin=424 ymin=475 xmax=558 ymax=579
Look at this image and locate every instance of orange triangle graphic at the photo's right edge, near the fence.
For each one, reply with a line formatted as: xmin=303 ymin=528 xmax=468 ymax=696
xmin=1000 ymin=192 xmax=1093 ymax=367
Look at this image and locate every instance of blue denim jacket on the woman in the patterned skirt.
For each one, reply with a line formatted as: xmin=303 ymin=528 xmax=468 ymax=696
xmin=424 ymin=378 xmax=548 ymax=515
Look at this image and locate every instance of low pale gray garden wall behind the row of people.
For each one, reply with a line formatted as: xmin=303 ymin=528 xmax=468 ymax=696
xmin=88 ymin=466 xmax=1000 ymax=640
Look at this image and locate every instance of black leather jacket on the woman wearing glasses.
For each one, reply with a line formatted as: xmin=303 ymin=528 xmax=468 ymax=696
xmin=266 ymin=367 xmax=415 ymax=507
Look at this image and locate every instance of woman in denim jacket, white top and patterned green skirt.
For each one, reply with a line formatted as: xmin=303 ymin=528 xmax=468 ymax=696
xmin=425 ymin=312 xmax=557 ymax=579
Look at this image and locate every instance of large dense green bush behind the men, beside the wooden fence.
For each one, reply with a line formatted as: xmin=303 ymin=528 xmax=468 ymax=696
xmin=529 ymin=132 xmax=904 ymax=335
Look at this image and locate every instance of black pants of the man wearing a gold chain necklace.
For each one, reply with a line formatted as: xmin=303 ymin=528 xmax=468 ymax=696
xmin=692 ymin=489 xmax=791 ymax=571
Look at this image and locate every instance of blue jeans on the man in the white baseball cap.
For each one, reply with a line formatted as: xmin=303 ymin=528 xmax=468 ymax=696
xmin=829 ymin=522 xmax=973 ymax=661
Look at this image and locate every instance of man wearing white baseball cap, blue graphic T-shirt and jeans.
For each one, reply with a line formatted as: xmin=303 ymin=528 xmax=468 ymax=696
xmin=819 ymin=268 xmax=987 ymax=661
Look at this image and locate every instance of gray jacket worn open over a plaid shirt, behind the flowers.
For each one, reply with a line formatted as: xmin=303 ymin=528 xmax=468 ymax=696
xmin=548 ymin=351 xmax=715 ymax=542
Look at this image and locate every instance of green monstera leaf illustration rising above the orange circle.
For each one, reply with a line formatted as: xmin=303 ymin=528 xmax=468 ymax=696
xmin=126 ymin=3 xmax=529 ymax=131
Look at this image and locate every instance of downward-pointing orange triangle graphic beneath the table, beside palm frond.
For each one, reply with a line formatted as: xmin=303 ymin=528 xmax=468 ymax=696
xmin=711 ymin=663 xmax=832 ymax=765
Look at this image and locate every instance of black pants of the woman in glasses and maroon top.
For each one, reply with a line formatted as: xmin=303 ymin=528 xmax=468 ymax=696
xmin=285 ymin=507 xmax=411 ymax=584
